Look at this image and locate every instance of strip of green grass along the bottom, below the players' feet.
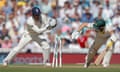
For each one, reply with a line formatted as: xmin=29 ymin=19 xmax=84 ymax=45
xmin=0 ymin=64 xmax=120 ymax=72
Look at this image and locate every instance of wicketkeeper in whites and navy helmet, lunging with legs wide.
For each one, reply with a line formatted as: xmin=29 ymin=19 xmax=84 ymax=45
xmin=3 ymin=7 xmax=56 ymax=66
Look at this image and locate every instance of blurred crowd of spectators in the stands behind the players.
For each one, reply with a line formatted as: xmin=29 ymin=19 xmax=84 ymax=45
xmin=0 ymin=0 xmax=120 ymax=63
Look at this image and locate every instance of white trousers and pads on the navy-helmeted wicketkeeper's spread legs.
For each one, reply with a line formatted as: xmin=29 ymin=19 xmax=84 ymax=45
xmin=3 ymin=33 xmax=50 ymax=63
